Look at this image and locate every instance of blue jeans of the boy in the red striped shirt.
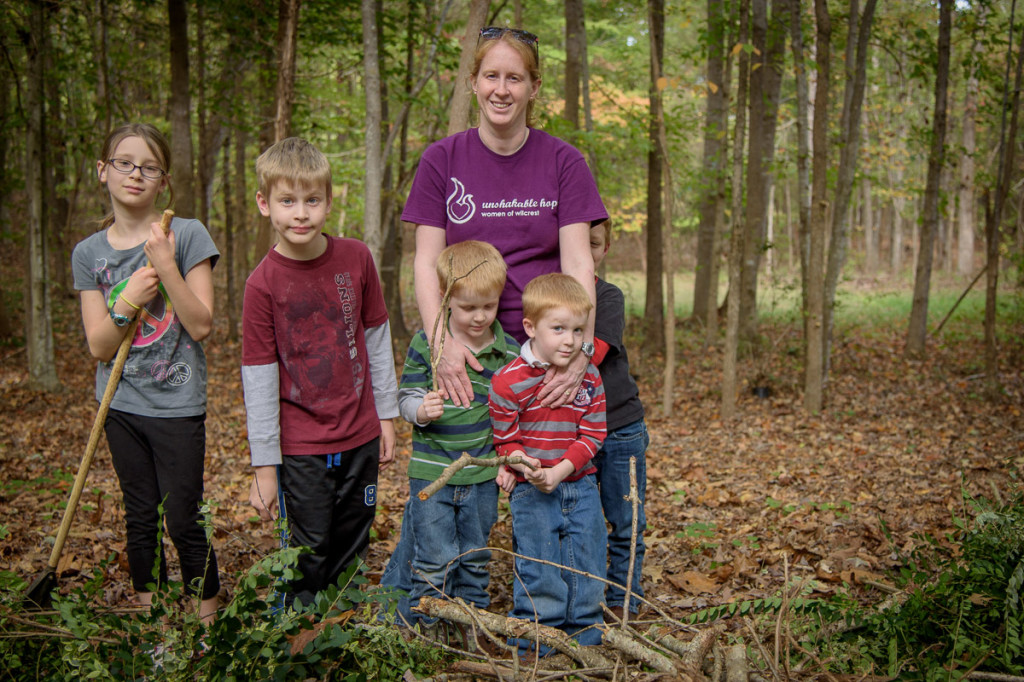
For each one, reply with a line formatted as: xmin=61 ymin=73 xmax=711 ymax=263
xmin=509 ymin=476 xmax=607 ymax=653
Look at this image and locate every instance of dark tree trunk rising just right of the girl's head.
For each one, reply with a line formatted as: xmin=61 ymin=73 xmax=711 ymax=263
xmin=167 ymin=0 xmax=196 ymax=217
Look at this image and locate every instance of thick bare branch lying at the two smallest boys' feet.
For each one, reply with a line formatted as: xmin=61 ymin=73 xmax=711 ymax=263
xmin=413 ymin=597 xmax=613 ymax=668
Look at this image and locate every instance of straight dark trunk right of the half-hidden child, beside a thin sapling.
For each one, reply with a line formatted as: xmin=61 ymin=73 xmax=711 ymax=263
xmin=644 ymin=0 xmax=668 ymax=352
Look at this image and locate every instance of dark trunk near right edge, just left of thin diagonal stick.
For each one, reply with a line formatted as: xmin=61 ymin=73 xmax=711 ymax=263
xmin=904 ymin=0 xmax=953 ymax=359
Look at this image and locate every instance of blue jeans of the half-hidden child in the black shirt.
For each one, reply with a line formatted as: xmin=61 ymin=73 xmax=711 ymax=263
xmin=594 ymin=419 xmax=650 ymax=613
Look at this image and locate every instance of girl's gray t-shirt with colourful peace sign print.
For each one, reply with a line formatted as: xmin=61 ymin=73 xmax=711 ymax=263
xmin=72 ymin=218 xmax=220 ymax=417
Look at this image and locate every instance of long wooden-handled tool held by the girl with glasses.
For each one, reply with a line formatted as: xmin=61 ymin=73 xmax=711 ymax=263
xmin=24 ymin=211 xmax=174 ymax=608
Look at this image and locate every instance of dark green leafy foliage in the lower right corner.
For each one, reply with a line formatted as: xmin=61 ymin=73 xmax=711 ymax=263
xmin=835 ymin=491 xmax=1024 ymax=680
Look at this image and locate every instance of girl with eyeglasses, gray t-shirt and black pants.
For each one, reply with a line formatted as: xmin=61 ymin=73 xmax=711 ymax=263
xmin=72 ymin=123 xmax=220 ymax=621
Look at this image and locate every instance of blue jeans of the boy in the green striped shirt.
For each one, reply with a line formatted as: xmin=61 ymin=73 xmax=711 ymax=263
xmin=381 ymin=478 xmax=498 ymax=623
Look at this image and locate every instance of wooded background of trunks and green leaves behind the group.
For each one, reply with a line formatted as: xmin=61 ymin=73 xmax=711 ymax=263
xmin=0 ymin=0 xmax=1024 ymax=417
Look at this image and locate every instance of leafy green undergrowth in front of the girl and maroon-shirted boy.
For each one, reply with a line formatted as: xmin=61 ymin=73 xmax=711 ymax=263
xmin=0 ymin=549 xmax=448 ymax=681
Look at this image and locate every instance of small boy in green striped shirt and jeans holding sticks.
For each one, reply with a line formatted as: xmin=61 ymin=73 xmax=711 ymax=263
xmin=382 ymin=241 xmax=519 ymax=621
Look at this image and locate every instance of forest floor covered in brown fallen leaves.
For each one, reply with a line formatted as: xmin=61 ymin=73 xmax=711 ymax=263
xmin=0 ymin=282 xmax=1024 ymax=675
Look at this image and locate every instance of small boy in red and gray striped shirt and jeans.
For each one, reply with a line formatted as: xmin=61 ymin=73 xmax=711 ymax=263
xmin=489 ymin=273 xmax=607 ymax=654
